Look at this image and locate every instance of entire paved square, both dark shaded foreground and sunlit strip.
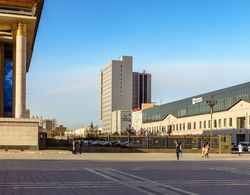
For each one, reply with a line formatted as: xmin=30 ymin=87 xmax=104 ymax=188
xmin=0 ymin=151 xmax=250 ymax=195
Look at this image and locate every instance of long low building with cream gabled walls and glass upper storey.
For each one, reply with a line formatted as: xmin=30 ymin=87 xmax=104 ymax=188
xmin=132 ymin=82 xmax=250 ymax=143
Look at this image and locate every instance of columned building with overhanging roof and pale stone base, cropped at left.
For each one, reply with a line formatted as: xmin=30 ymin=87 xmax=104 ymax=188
xmin=0 ymin=0 xmax=44 ymax=148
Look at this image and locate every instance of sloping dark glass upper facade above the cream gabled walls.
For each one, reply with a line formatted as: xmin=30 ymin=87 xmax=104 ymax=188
xmin=142 ymin=82 xmax=250 ymax=123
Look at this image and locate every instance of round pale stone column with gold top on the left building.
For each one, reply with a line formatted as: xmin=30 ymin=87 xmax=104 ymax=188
xmin=15 ymin=22 xmax=27 ymax=118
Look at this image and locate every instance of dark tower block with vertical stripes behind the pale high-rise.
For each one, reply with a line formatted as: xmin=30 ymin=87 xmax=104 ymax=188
xmin=132 ymin=71 xmax=151 ymax=109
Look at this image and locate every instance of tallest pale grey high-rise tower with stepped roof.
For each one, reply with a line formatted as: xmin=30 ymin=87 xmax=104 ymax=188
xmin=101 ymin=56 xmax=133 ymax=132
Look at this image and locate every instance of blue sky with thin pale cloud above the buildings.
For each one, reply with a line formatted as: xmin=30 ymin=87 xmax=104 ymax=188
xmin=27 ymin=0 xmax=250 ymax=128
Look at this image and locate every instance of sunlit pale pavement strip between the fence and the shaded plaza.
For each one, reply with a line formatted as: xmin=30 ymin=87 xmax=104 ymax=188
xmin=0 ymin=150 xmax=250 ymax=161
